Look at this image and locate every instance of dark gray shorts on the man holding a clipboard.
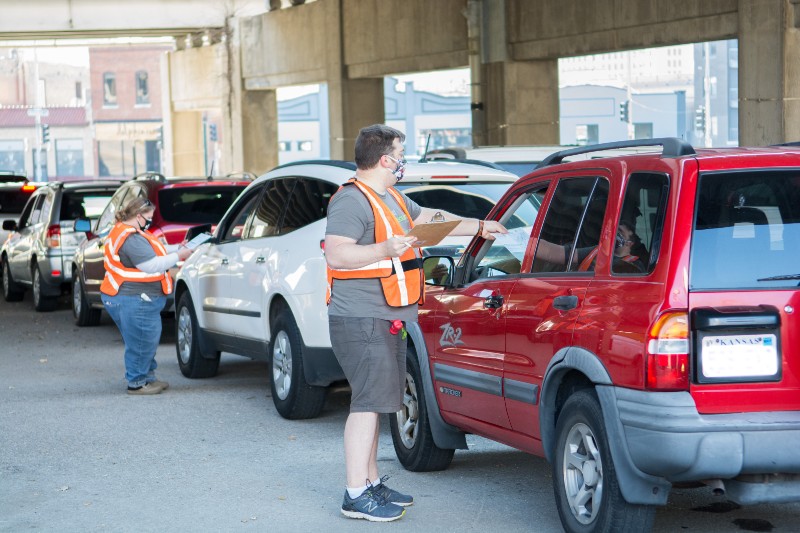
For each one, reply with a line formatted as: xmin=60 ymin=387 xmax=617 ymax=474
xmin=328 ymin=316 xmax=406 ymax=413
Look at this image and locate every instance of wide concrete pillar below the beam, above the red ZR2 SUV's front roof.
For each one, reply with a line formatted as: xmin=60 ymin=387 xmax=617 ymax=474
xmin=483 ymin=59 xmax=559 ymax=146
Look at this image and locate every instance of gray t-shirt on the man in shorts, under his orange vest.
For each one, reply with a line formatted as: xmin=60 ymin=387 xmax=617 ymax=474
xmin=325 ymin=185 xmax=422 ymax=322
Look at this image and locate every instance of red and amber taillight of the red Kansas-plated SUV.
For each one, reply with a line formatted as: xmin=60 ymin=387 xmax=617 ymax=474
xmin=647 ymin=312 xmax=689 ymax=390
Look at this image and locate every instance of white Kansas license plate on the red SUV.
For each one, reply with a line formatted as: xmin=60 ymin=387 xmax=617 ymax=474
xmin=700 ymin=334 xmax=778 ymax=379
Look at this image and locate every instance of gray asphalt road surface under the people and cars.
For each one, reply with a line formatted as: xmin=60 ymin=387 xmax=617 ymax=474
xmin=0 ymin=295 xmax=800 ymax=533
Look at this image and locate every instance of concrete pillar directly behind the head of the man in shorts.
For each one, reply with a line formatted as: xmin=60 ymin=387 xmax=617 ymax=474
xmin=328 ymin=77 xmax=384 ymax=161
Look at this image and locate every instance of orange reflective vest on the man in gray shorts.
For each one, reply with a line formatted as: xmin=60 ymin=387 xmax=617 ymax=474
xmin=327 ymin=178 xmax=425 ymax=307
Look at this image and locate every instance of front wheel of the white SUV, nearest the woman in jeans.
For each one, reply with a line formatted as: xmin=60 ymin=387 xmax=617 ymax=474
xmin=175 ymin=291 xmax=220 ymax=379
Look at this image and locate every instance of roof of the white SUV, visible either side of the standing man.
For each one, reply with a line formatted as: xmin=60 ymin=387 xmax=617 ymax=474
xmin=258 ymin=160 xmax=518 ymax=184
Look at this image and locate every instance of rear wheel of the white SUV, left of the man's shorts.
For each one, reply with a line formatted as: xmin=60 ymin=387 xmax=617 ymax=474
xmin=269 ymin=309 xmax=327 ymax=420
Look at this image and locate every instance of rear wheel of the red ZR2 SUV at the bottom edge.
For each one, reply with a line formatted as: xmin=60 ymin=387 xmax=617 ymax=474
xmin=552 ymin=390 xmax=655 ymax=533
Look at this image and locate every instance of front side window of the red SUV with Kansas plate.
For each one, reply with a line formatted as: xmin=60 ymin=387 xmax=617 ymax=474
xmin=475 ymin=186 xmax=547 ymax=278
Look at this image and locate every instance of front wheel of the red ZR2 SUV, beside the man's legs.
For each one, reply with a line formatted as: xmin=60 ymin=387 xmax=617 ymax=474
xmin=390 ymin=343 xmax=455 ymax=472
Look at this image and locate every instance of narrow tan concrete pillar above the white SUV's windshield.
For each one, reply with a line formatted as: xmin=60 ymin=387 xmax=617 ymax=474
xmin=241 ymin=89 xmax=278 ymax=176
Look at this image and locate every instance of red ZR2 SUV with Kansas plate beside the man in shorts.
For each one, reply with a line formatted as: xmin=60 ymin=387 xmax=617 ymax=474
xmin=392 ymin=139 xmax=800 ymax=532
